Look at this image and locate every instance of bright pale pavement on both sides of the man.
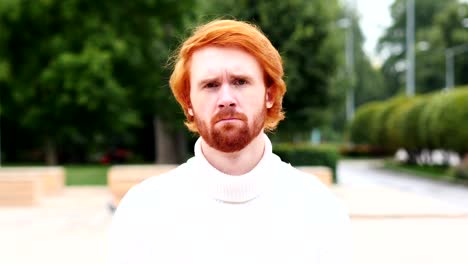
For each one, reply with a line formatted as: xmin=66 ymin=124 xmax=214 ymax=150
xmin=0 ymin=161 xmax=468 ymax=264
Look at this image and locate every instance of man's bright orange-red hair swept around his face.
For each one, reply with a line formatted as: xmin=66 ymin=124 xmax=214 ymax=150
xmin=169 ymin=20 xmax=286 ymax=132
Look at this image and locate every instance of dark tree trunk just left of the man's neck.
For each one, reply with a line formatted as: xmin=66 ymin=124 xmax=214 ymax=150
xmin=153 ymin=117 xmax=178 ymax=164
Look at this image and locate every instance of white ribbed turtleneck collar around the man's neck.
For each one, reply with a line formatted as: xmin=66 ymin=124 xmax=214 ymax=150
xmin=194 ymin=134 xmax=276 ymax=203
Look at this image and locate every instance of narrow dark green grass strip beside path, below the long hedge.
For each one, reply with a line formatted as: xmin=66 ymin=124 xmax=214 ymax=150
xmin=384 ymin=160 xmax=456 ymax=182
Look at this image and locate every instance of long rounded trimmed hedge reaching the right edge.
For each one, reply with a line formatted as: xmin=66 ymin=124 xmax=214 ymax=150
xmin=349 ymin=87 xmax=468 ymax=155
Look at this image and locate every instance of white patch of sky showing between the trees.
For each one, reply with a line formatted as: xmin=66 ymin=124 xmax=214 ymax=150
xmin=354 ymin=0 xmax=394 ymax=65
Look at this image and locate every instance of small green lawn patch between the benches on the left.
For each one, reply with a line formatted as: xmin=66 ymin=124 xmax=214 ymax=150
xmin=65 ymin=165 xmax=109 ymax=186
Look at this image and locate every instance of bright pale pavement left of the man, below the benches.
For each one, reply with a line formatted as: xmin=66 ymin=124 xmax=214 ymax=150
xmin=0 ymin=187 xmax=111 ymax=264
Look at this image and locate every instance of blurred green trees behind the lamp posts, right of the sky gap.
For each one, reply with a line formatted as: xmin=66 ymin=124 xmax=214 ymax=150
xmin=378 ymin=0 xmax=468 ymax=94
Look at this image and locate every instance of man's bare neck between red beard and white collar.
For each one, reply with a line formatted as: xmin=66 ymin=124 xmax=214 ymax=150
xmin=201 ymin=132 xmax=265 ymax=175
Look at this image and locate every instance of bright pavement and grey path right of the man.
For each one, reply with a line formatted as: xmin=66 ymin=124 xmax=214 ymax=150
xmin=333 ymin=161 xmax=468 ymax=264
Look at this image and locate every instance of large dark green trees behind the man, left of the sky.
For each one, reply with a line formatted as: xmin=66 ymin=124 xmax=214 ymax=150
xmin=0 ymin=0 xmax=380 ymax=163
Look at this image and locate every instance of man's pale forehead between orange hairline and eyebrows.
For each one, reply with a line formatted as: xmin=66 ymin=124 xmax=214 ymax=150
xmin=190 ymin=46 xmax=263 ymax=79
